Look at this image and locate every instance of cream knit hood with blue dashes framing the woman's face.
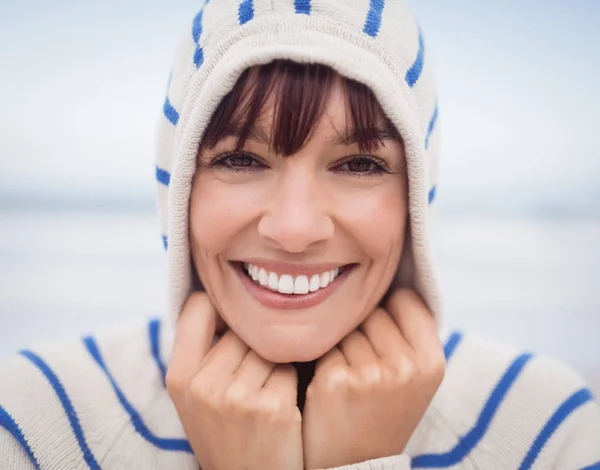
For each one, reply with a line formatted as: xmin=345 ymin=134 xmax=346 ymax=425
xmin=156 ymin=0 xmax=441 ymax=325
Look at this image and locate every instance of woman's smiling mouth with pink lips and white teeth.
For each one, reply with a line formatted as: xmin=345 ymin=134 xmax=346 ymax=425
xmin=231 ymin=261 xmax=357 ymax=310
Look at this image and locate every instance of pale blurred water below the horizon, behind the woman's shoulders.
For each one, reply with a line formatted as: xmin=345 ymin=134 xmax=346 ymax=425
xmin=0 ymin=209 xmax=600 ymax=394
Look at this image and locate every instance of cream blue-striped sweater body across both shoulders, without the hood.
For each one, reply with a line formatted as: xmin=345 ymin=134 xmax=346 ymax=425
xmin=0 ymin=320 xmax=600 ymax=470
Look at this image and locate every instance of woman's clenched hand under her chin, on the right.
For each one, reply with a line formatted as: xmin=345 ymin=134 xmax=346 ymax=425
xmin=302 ymin=289 xmax=445 ymax=469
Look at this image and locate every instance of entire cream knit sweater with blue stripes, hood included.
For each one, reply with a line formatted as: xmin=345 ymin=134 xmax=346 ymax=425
xmin=0 ymin=0 xmax=600 ymax=470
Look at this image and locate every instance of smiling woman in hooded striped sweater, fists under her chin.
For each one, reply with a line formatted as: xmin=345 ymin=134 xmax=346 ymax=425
xmin=0 ymin=0 xmax=600 ymax=469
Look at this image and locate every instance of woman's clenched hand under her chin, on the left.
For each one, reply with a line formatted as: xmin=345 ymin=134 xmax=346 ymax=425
xmin=166 ymin=293 xmax=303 ymax=470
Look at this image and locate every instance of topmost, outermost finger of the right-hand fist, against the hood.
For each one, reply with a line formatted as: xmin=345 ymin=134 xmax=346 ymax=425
xmin=387 ymin=289 xmax=441 ymax=355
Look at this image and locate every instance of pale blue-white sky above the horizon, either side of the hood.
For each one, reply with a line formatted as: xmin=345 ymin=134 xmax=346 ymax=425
xmin=0 ymin=0 xmax=600 ymax=215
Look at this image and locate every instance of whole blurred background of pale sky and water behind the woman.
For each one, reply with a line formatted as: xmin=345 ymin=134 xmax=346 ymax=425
xmin=0 ymin=0 xmax=600 ymax=395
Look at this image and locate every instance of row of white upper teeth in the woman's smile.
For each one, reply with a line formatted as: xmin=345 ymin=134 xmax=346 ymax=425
xmin=243 ymin=263 xmax=340 ymax=295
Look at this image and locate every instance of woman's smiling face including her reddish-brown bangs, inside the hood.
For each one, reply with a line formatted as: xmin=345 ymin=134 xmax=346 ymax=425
xmin=190 ymin=61 xmax=407 ymax=363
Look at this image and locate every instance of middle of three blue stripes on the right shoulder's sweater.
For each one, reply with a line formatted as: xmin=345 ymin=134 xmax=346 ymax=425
xmin=412 ymin=354 xmax=531 ymax=468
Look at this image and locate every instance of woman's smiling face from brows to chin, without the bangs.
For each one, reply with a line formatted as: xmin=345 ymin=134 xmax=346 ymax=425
xmin=190 ymin=80 xmax=407 ymax=363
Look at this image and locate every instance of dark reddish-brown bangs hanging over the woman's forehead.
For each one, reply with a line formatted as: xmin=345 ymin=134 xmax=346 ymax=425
xmin=201 ymin=60 xmax=401 ymax=156
